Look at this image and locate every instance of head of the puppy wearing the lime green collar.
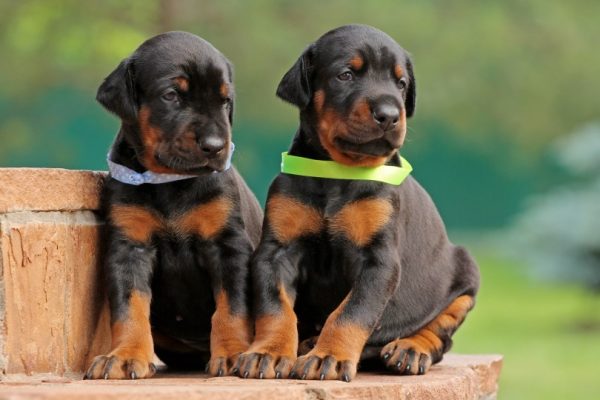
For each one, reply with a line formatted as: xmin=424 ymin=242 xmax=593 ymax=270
xmin=277 ymin=25 xmax=416 ymax=166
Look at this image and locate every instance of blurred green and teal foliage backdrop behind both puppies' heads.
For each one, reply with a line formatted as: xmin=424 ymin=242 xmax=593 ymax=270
xmin=0 ymin=0 xmax=600 ymax=228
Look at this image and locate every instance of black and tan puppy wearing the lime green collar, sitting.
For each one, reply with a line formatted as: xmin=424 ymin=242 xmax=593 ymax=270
xmin=234 ymin=25 xmax=479 ymax=381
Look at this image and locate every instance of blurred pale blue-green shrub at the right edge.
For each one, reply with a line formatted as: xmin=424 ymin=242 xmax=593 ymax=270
xmin=510 ymin=125 xmax=600 ymax=291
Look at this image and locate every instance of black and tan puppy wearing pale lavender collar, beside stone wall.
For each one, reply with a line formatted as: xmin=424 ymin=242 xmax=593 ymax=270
xmin=85 ymin=32 xmax=262 ymax=379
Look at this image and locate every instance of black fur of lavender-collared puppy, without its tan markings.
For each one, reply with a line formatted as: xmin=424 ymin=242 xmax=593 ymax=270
xmin=88 ymin=32 xmax=262 ymax=378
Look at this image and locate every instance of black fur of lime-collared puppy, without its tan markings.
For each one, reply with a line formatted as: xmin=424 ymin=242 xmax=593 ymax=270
xmin=240 ymin=25 xmax=479 ymax=380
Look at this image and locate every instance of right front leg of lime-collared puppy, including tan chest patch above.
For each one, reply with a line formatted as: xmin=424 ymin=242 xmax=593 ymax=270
xmin=290 ymin=197 xmax=400 ymax=382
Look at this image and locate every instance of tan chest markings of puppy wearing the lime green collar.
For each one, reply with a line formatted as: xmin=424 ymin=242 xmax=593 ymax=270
xmin=267 ymin=194 xmax=394 ymax=247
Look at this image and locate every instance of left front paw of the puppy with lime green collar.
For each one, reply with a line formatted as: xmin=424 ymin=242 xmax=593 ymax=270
xmin=233 ymin=351 xmax=295 ymax=379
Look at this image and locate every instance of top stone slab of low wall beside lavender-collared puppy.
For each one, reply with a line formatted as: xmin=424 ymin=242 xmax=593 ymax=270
xmin=0 ymin=168 xmax=106 ymax=213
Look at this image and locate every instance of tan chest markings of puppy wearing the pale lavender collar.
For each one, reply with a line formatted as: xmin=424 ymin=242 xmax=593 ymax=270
xmin=110 ymin=196 xmax=234 ymax=242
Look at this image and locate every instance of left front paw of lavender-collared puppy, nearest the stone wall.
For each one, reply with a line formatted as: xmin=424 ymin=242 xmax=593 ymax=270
xmin=83 ymin=349 xmax=156 ymax=379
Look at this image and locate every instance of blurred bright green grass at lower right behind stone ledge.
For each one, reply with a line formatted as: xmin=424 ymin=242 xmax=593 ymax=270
xmin=453 ymin=251 xmax=600 ymax=400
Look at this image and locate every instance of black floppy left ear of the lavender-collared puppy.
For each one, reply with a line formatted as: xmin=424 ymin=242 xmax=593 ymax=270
xmin=96 ymin=58 xmax=138 ymax=122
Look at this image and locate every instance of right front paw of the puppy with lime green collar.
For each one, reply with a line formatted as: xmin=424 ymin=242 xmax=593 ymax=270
xmin=290 ymin=350 xmax=356 ymax=382
